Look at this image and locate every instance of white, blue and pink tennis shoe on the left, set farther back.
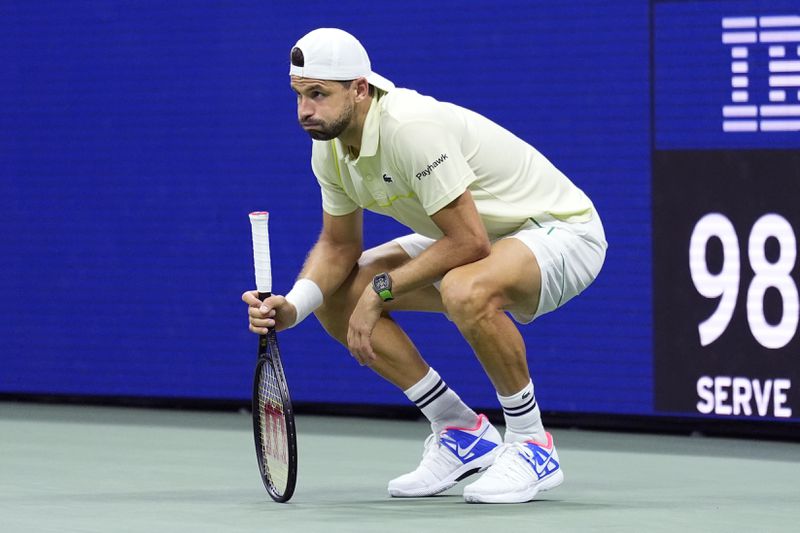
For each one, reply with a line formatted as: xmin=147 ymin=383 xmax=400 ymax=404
xmin=389 ymin=415 xmax=503 ymax=498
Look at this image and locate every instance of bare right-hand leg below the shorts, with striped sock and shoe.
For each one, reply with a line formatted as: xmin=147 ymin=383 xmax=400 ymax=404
xmin=441 ymin=239 xmax=564 ymax=503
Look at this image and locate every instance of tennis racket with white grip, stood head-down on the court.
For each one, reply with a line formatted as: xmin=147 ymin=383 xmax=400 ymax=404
xmin=250 ymin=211 xmax=297 ymax=503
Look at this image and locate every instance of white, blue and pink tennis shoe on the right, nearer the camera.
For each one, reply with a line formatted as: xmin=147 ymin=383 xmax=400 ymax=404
xmin=464 ymin=433 xmax=564 ymax=503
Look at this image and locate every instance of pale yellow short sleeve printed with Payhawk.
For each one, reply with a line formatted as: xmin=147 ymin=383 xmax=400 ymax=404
xmin=384 ymin=120 xmax=475 ymax=215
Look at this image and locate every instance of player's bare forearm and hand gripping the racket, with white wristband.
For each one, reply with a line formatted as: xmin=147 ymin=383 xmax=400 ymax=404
xmin=242 ymin=209 xmax=363 ymax=335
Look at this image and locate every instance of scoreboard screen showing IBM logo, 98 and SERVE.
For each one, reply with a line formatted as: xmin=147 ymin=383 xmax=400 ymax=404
xmin=652 ymin=2 xmax=800 ymax=420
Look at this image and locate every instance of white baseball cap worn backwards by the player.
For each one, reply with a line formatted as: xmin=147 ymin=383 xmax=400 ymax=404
xmin=289 ymin=28 xmax=394 ymax=91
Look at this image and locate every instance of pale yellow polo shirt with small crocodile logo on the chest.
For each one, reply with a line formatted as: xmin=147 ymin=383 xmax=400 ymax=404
xmin=311 ymin=89 xmax=593 ymax=240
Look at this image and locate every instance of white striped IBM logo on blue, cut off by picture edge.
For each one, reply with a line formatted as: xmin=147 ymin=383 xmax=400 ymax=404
xmin=722 ymin=15 xmax=800 ymax=132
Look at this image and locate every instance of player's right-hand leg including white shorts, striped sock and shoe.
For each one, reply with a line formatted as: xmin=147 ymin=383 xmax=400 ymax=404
xmin=442 ymin=233 xmax=605 ymax=503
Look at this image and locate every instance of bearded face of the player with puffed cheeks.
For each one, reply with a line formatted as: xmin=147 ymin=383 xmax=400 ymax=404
xmin=292 ymin=76 xmax=355 ymax=141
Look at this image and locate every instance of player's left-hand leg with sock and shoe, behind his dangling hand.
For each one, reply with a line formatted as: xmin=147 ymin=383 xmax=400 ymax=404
xmin=316 ymin=242 xmax=502 ymax=497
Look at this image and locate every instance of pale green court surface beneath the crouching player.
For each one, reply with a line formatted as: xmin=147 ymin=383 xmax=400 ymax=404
xmin=0 ymin=403 xmax=800 ymax=533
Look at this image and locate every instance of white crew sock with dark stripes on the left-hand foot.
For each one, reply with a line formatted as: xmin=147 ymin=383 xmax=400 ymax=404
xmin=403 ymin=368 xmax=478 ymax=435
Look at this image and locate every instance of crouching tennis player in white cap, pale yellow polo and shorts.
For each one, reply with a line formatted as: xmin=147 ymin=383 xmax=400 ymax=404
xmin=242 ymin=28 xmax=607 ymax=503
